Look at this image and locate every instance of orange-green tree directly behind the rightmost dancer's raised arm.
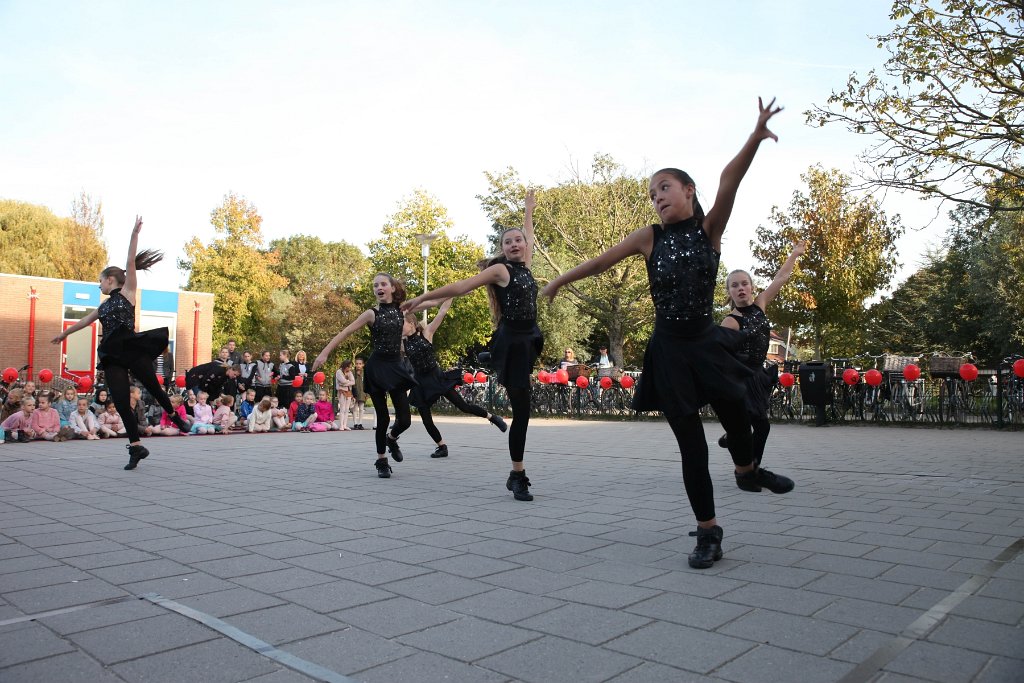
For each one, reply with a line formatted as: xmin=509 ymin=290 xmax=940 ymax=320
xmin=751 ymin=166 xmax=903 ymax=358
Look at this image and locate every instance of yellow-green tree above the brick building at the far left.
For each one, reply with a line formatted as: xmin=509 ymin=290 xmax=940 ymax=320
xmin=0 ymin=200 xmax=108 ymax=282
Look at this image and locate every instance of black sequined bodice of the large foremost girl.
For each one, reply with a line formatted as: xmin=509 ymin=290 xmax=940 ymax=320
xmin=647 ymin=218 xmax=720 ymax=331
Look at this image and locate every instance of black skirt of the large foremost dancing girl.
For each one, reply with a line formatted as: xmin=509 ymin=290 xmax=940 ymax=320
xmin=633 ymin=322 xmax=752 ymax=418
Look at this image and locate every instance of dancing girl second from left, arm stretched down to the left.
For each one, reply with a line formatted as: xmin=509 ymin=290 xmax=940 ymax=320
xmin=309 ymin=272 xmax=416 ymax=479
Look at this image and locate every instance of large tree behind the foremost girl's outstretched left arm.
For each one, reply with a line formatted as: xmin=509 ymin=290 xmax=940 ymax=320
xmin=479 ymin=155 xmax=656 ymax=368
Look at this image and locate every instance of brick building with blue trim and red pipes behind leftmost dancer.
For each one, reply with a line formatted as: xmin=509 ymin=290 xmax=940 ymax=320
xmin=0 ymin=273 xmax=213 ymax=379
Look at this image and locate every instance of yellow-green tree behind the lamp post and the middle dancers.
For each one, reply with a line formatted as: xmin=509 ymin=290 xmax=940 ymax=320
xmin=359 ymin=190 xmax=492 ymax=366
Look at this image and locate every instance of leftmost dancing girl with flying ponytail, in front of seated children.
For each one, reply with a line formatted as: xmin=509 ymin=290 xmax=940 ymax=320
xmin=52 ymin=216 xmax=186 ymax=470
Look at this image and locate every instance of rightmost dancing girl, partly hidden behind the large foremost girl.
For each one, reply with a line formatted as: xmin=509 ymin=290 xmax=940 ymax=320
xmin=718 ymin=242 xmax=807 ymax=465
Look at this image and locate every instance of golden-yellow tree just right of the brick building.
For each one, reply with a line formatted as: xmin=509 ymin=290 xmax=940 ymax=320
xmin=178 ymin=194 xmax=288 ymax=347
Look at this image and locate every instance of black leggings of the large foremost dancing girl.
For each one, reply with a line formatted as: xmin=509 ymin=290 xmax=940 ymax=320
xmin=669 ymin=400 xmax=753 ymax=521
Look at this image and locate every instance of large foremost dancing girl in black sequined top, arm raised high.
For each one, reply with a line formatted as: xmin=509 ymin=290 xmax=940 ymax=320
xmin=543 ymin=98 xmax=793 ymax=568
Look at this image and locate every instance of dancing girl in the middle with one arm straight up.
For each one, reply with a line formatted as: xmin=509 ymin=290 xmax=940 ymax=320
xmin=402 ymin=190 xmax=544 ymax=501
